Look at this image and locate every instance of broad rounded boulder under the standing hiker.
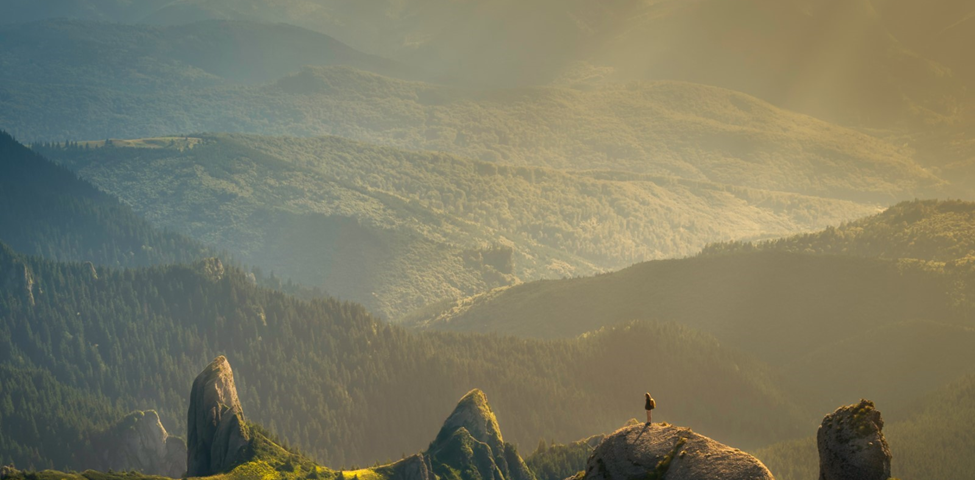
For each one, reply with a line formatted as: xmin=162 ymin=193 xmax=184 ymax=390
xmin=577 ymin=423 xmax=772 ymax=480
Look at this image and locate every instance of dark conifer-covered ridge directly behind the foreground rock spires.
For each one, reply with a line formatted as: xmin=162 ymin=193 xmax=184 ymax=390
xmin=0 ymin=242 xmax=812 ymax=468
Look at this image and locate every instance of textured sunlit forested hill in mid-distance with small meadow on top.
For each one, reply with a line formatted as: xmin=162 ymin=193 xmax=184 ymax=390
xmin=37 ymin=135 xmax=872 ymax=319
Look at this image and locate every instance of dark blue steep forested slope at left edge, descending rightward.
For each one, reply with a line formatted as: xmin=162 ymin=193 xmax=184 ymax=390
xmin=0 ymin=131 xmax=208 ymax=267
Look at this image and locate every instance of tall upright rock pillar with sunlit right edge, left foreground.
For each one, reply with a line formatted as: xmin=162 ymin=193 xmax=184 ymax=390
xmin=186 ymin=355 xmax=250 ymax=477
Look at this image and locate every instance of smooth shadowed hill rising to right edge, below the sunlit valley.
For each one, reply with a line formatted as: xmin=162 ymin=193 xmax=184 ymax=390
xmin=406 ymin=201 xmax=975 ymax=416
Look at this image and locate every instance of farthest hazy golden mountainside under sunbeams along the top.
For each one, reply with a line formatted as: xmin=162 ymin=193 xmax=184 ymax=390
xmin=7 ymin=0 xmax=973 ymax=127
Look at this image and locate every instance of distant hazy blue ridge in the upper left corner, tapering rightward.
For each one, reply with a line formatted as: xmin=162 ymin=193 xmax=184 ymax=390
xmin=0 ymin=19 xmax=406 ymax=89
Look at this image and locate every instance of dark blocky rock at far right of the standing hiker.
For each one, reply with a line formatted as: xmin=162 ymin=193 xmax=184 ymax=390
xmin=816 ymin=400 xmax=890 ymax=480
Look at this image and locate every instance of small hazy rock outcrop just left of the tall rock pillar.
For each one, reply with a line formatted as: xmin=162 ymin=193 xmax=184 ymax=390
xmin=93 ymin=410 xmax=186 ymax=478
